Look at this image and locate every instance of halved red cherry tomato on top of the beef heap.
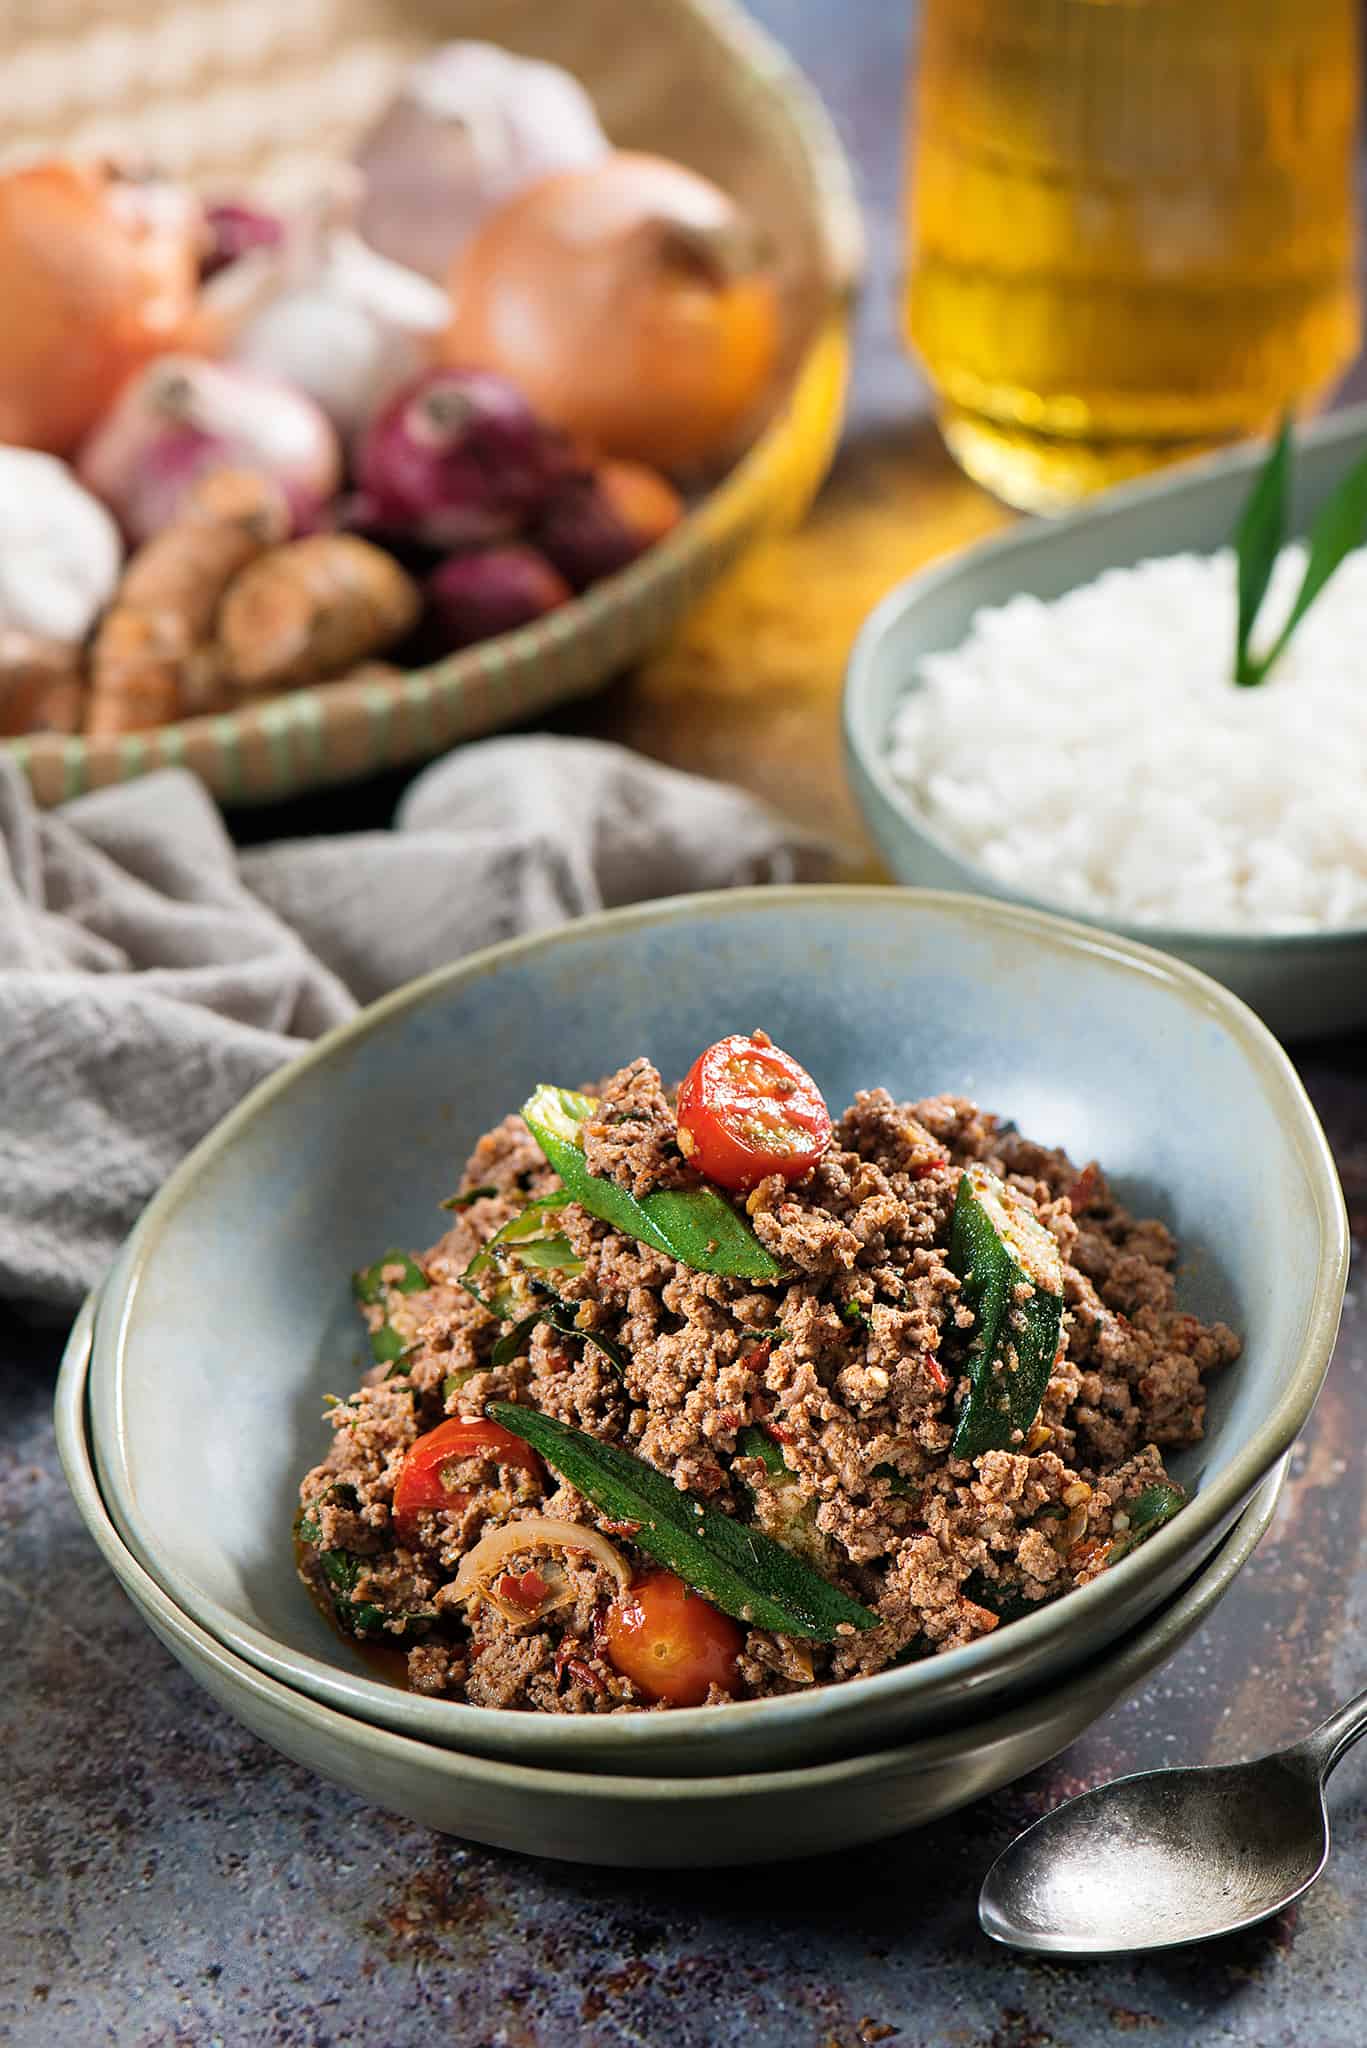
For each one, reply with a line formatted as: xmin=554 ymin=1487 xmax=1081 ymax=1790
xmin=678 ymin=1030 xmax=830 ymax=1194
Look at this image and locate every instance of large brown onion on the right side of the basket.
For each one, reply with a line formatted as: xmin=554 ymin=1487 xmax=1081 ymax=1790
xmin=439 ymin=152 xmax=781 ymax=473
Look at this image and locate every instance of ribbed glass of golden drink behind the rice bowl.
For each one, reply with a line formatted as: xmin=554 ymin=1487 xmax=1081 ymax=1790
xmin=906 ymin=0 xmax=1361 ymax=510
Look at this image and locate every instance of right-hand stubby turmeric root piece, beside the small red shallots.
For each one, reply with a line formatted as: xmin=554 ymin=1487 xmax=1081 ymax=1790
xmin=217 ymin=532 xmax=422 ymax=694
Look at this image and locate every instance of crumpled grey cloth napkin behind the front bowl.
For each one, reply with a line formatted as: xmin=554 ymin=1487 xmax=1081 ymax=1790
xmin=0 ymin=735 xmax=830 ymax=1311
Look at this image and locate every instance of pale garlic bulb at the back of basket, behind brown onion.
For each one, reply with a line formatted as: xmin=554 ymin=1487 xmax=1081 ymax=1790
xmin=355 ymin=43 xmax=609 ymax=279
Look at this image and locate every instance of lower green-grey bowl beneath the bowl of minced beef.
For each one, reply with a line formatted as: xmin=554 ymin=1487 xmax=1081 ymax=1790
xmin=55 ymin=1303 xmax=1287 ymax=1870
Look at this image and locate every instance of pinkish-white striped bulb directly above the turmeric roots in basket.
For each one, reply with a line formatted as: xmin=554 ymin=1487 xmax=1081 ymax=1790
xmin=76 ymin=356 xmax=342 ymax=543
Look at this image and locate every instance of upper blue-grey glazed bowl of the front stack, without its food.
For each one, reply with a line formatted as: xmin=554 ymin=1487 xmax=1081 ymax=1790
xmin=90 ymin=889 xmax=1347 ymax=1774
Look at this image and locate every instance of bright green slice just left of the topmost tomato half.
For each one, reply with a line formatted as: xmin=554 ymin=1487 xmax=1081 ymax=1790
xmin=523 ymin=1083 xmax=783 ymax=1280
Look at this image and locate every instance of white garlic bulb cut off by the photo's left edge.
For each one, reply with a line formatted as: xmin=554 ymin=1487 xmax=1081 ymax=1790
xmin=0 ymin=446 xmax=123 ymax=643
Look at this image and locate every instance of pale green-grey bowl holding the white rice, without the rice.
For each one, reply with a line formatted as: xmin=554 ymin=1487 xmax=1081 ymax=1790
xmin=844 ymin=406 xmax=1367 ymax=1038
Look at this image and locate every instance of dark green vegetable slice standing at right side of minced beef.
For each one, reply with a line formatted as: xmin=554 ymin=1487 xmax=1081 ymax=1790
xmin=949 ymin=1165 xmax=1064 ymax=1458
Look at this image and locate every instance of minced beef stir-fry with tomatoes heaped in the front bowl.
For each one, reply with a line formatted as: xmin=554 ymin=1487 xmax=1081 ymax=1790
xmin=297 ymin=1034 xmax=1240 ymax=1714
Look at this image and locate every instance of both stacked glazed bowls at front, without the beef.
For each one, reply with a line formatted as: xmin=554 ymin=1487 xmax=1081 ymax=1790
xmin=57 ymin=889 xmax=1347 ymax=1866
